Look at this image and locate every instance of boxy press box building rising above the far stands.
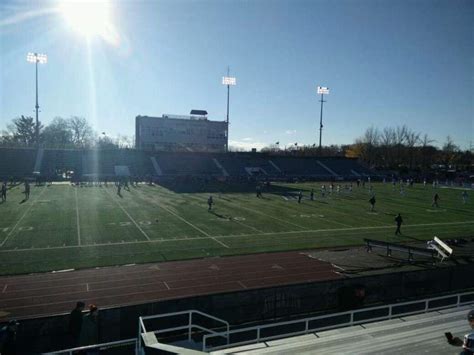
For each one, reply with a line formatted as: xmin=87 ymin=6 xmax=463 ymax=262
xmin=135 ymin=110 xmax=227 ymax=152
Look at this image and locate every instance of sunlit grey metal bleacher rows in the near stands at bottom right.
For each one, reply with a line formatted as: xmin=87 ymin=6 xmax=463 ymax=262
xmin=216 ymin=306 xmax=473 ymax=355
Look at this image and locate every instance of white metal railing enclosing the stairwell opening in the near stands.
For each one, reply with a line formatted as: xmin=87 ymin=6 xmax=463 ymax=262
xmin=137 ymin=310 xmax=230 ymax=354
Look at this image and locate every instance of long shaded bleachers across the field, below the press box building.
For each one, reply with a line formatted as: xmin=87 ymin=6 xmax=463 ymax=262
xmin=0 ymin=148 xmax=378 ymax=180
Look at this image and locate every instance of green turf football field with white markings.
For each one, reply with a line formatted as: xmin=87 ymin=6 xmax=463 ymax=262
xmin=0 ymin=183 xmax=474 ymax=274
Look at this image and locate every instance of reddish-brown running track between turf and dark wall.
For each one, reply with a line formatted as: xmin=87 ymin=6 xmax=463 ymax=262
xmin=0 ymin=252 xmax=343 ymax=321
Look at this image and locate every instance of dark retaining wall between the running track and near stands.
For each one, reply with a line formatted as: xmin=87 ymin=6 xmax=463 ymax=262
xmin=10 ymin=264 xmax=474 ymax=354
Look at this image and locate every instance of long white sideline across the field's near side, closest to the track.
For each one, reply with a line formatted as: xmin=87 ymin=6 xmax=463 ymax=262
xmin=0 ymin=221 xmax=474 ymax=253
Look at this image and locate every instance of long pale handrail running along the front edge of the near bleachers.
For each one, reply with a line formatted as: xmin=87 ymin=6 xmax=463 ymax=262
xmin=202 ymin=291 xmax=474 ymax=351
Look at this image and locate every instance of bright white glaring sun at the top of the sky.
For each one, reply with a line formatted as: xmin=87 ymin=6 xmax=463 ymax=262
xmin=59 ymin=0 xmax=114 ymax=40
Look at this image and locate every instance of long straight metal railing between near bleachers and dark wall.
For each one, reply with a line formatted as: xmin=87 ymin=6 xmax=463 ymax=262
xmin=202 ymin=291 xmax=474 ymax=351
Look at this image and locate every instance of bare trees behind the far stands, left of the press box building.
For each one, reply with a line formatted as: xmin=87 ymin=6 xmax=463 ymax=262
xmin=0 ymin=116 xmax=133 ymax=149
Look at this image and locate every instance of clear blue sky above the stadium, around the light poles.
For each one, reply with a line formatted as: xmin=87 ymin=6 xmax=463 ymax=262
xmin=0 ymin=0 xmax=474 ymax=148
